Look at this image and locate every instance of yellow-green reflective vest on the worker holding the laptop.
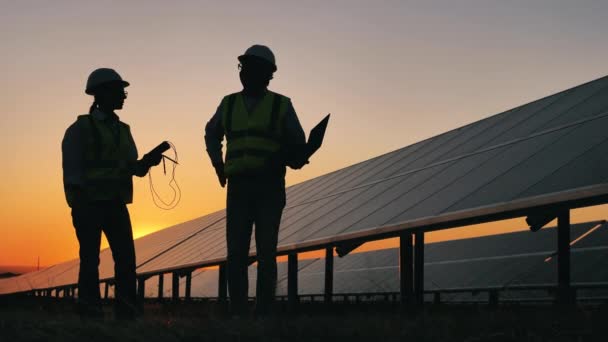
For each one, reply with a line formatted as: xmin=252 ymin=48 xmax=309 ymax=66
xmin=221 ymin=91 xmax=289 ymax=177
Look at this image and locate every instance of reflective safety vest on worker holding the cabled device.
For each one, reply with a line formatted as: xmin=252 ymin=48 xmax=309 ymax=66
xmin=66 ymin=114 xmax=137 ymax=206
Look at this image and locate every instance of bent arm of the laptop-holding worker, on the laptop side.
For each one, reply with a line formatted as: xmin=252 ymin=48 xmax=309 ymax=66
xmin=283 ymin=101 xmax=308 ymax=169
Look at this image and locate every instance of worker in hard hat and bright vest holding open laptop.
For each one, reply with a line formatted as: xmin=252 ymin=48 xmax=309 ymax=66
xmin=205 ymin=45 xmax=306 ymax=315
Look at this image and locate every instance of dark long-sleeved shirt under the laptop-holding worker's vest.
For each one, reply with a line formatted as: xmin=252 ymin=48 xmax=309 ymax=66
xmin=205 ymin=94 xmax=306 ymax=176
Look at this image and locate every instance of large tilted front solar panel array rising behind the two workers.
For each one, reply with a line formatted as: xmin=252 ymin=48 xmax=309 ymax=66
xmin=0 ymin=77 xmax=608 ymax=293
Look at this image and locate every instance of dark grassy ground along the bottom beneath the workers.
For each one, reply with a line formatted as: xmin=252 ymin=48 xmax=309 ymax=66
xmin=0 ymin=299 xmax=608 ymax=342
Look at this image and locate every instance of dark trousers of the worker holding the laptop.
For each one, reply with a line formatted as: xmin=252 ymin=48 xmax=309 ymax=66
xmin=226 ymin=179 xmax=285 ymax=314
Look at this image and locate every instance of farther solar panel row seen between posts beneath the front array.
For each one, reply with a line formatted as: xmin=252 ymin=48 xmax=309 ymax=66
xmin=139 ymin=221 xmax=608 ymax=300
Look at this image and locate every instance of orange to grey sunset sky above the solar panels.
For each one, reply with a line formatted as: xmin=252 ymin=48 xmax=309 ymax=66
xmin=0 ymin=0 xmax=608 ymax=265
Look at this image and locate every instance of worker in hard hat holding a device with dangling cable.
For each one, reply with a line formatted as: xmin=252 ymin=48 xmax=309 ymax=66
xmin=62 ymin=68 xmax=161 ymax=319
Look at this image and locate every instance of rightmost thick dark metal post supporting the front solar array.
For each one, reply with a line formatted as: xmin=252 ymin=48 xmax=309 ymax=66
xmin=557 ymin=210 xmax=572 ymax=304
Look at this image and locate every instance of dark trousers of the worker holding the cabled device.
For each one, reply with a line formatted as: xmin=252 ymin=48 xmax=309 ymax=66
xmin=72 ymin=201 xmax=136 ymax=316
